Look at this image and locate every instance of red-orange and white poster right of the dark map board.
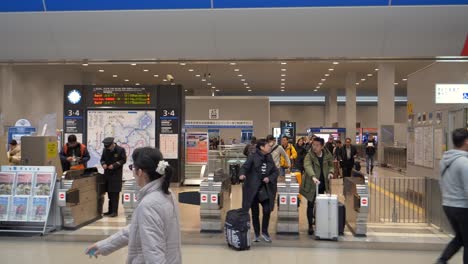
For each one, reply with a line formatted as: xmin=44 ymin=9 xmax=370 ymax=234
xmin=185 ymin=132 xmax=209 ymax=164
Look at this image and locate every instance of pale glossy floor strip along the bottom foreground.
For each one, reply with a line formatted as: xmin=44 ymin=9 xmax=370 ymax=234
xmin=0 ymin=238 xmax=462 ymax=264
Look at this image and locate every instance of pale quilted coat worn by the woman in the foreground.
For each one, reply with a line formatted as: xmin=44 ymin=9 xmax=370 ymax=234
xmin=97 ymin=178 xmax=182 ymax=264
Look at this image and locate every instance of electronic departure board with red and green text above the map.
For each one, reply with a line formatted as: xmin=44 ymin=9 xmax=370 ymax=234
xmin=88 ymin=87 xmax=156 ymax=107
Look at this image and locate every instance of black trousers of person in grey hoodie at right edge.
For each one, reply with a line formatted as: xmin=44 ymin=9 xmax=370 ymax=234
xmin=440 ymin=206 xmax=468 ymax=264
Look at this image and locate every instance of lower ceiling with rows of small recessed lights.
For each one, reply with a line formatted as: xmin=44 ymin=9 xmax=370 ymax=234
xmin=80 ymin=60 xmax=432 ymax=96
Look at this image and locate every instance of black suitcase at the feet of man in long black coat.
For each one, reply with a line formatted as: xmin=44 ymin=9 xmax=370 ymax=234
xmin=224 ymin=209 xmax=250 ymax=250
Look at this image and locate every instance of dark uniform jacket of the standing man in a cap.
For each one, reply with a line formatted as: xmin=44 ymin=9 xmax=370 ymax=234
xmin=101 ymin=145 xmax=127 ymax=192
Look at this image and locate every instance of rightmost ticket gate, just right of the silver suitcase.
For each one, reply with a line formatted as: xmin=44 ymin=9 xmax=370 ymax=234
xmin=344 ymin=177 xmax=370 ymax=236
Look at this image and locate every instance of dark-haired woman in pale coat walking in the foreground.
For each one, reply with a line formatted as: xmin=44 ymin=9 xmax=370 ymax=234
xmin=86 ymin=147 xmax=182 ymax=264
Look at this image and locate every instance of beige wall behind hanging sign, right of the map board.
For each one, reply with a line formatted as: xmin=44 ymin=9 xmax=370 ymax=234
xmin=185 ymin=96 xmax=271 ymax=143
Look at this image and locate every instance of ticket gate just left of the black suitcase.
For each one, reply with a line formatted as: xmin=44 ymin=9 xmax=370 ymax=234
xmin=200 ymin=173 xmax=231 ymax=232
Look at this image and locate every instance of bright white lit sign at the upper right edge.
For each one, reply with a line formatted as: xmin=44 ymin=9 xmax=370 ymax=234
xmin=435 ymin=84 xmax=468 ymax=104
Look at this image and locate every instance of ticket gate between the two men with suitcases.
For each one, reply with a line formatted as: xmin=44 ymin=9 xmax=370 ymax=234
xmin=276 ymin=174 xmax=300 ymax=234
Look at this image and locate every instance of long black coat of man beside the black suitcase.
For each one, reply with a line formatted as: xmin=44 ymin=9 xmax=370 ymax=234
xmin=240 ymin=150 xmax=279 ymax=211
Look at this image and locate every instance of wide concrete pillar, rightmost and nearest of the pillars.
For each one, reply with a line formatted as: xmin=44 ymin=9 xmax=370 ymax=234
xmin=377 ymin=64 xmax=395 ymax=163
